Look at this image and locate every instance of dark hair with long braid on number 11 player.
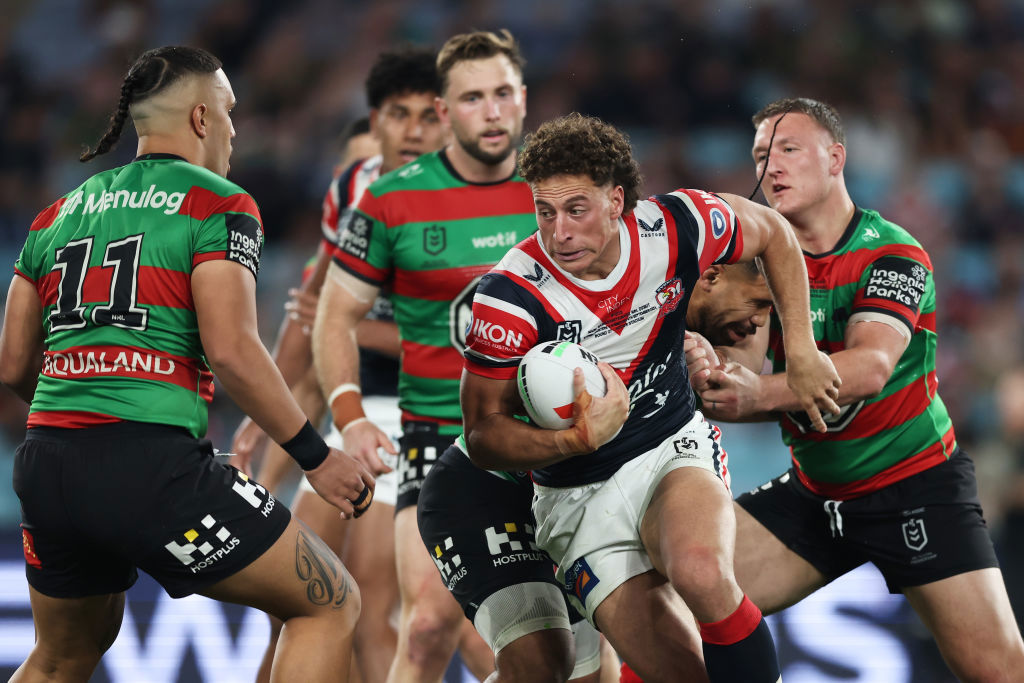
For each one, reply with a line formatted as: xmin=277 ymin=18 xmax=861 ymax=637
xmin=79 ymin=45 xmax=221 ymax=162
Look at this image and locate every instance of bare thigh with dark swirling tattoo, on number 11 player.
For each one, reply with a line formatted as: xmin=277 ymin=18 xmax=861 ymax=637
xmin=203 ymin=517 xmax=359 ymax=624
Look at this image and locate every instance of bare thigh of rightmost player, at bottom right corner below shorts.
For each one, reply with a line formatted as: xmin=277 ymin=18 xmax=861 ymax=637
xmin=903 ymin=567 xmax=1024 ymax=680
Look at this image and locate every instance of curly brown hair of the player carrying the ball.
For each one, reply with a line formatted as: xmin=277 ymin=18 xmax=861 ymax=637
xmin=519 ymin=113 xmax=643 ymax=213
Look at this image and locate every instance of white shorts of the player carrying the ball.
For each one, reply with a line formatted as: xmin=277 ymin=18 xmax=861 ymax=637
xmin=534 ymin=412 xmax=729 ymax=624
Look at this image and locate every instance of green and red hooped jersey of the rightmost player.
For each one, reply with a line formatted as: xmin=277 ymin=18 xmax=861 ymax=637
xmin=769 ymin=209 xmax=956 ymax=500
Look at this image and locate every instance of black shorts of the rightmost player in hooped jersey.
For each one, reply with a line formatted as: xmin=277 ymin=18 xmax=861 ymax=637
xmin=736 ymin=449 xmax=998 ymax=593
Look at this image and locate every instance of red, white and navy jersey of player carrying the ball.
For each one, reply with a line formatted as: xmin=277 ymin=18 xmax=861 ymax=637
xmin=466 ymin=189 xmax=742 ymax=486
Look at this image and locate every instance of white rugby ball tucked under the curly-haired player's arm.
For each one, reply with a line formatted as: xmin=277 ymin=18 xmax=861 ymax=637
xmin=516 ymin=341 xmax=607 ymax=429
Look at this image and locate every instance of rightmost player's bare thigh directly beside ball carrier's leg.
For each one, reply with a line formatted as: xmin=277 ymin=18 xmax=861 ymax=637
xmin=733 ymin=505 xmax=828 ymax=614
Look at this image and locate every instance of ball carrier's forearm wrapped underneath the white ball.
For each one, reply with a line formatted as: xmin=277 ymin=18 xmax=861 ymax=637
xmin=466 ymin=413 xmax=577 ymax=470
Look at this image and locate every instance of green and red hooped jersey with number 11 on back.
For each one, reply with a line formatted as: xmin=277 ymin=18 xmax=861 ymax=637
xmin=14 ymin=155 xmax=263 ymax=436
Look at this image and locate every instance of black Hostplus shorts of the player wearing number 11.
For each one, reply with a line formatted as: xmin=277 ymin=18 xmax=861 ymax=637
xmin=13 ymin=422 xmax=291 ymax=598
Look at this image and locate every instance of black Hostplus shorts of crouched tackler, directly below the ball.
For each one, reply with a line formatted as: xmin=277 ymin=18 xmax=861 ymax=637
xmin=417 ymin=445 xmax=559 ymax=621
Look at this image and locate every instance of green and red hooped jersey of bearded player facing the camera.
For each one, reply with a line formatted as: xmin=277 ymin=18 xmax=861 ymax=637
xmin=334 ymin=151 xmax=537 ymax=436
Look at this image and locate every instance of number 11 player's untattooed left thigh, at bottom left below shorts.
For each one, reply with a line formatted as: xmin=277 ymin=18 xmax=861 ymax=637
xmin=29 ymin=586 xmax=125 ymax=659
